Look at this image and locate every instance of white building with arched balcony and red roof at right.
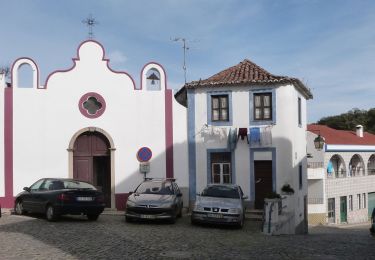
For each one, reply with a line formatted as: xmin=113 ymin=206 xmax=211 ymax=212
xmin=307 ymin=125 xmax=375 ymax=224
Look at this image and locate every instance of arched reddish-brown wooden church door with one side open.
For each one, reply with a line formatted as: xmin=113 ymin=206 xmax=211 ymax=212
xmin=73 ymin=132 xmax=111 ymax=207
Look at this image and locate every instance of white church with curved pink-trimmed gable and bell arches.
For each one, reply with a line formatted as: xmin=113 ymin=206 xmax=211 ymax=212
xmin=0 ymin=40 xmax=188 ymax=209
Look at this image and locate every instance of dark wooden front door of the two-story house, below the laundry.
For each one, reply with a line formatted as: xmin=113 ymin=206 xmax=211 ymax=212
xmin=254 ymin=161 xmax=272 ymax=209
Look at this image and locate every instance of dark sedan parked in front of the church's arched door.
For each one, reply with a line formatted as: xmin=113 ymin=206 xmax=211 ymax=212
xmin=14 ymin=178 xmax=105 ymax=221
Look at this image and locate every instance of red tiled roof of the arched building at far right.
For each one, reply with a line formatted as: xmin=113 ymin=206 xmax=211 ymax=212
xmin=307 ymin=124 xmax=375 ymax=145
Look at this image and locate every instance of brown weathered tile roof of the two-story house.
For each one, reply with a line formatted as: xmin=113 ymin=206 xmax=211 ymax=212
xmin=184 ymin=59 xmax=312 ymax=98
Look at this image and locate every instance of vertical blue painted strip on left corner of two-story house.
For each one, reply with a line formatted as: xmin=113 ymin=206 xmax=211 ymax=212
xmin=187 ymin=89 xmax=197 ymax=201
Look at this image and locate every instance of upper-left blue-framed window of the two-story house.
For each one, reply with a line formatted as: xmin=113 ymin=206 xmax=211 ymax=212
xmin=207 ymin=91 xmax=233 ymax=126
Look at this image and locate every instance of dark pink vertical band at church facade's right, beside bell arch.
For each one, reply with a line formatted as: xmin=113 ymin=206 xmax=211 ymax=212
xmin=165 ymin=89 xmax=174 ymax=178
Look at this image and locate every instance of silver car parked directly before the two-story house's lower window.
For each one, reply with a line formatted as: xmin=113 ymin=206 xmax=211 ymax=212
xmin=191 ymin=184 xmax=247 ymax=227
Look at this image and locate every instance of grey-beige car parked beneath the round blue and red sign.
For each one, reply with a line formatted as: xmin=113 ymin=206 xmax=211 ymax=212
xmin=125 ymin=179 xmax=183 ymax=223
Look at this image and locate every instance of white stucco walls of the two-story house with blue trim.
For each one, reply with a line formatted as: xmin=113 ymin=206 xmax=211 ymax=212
xmin=195 ymin=85 xmax=307 ymax=228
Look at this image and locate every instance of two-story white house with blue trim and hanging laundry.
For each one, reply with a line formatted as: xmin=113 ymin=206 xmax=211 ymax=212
xmin=175 ymin=59 xmax=312 ymax=233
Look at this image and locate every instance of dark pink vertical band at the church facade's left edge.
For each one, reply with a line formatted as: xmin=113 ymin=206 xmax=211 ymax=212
xmin=0 ymin=87 xmax=14 ymax=208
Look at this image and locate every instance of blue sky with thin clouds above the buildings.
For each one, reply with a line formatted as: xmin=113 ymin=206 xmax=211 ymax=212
xmin=0 ymin=0 xmax=375 ymax=122
